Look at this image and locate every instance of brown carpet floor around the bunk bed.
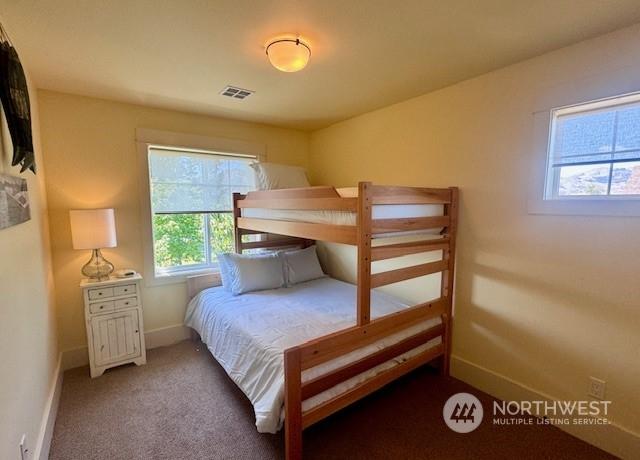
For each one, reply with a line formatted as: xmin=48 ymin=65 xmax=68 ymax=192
xmin=50 ymin=341 xmax=611 ymax=460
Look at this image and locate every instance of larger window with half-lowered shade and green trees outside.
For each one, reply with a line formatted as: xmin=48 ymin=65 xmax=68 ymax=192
xmin=148 ymin=146 xmax=256 ymax=276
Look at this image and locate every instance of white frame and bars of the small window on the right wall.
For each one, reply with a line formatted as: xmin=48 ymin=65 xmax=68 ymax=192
xmin=544 ymin=92 xmax=640 ymax=201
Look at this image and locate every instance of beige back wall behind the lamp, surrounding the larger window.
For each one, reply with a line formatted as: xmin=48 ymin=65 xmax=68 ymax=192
xmin=38 ymin=91 xmax=309 ymax=351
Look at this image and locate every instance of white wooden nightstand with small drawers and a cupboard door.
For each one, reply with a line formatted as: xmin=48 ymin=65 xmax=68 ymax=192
xmin=80 ymin=275 xmax=147 ymax=377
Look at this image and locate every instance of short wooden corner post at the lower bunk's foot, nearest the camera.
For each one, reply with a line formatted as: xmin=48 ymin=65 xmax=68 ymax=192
xmin=284 ymin=347 xmax=302 ymax=460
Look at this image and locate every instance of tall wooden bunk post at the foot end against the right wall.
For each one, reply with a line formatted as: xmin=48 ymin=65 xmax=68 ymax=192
xmin=440 ymin=187 xmax=458 ymax=375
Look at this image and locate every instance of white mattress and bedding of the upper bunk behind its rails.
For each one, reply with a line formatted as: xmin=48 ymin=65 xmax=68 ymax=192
xmin=242 ymin=187 xmax=444 ymax=236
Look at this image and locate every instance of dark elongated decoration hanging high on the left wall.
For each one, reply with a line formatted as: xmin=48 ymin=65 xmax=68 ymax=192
xmin=0 ymin=24 xmax=36 ymax=173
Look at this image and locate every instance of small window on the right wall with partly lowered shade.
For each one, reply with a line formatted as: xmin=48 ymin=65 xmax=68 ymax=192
xmin=545 ymin=94 xmax=640 ymax=200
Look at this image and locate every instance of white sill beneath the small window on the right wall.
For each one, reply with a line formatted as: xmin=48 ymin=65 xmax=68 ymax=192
xmin=528 ymin=198 xmax=640 ymax=217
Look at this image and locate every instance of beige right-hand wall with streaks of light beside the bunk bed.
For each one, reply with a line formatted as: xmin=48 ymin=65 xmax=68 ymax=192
xmin=310 ymin=27 xmax=640 ymax=433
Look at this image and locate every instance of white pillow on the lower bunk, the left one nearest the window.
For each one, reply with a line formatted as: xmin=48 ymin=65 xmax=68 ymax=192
xmin=218 ymin=253 xmax=286 ymax=295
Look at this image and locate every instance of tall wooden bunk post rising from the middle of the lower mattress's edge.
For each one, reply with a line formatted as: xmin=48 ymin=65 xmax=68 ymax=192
xmin=356 ymin=182 xmax=372 ymax=326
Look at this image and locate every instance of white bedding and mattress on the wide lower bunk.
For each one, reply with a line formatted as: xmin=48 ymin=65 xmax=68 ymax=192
xmin=185 ymin=278 xmax=441 ymax=433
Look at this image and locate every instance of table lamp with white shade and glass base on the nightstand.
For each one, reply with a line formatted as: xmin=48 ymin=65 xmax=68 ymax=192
xmin=69 ymin=209 xmax=118 ymax=281
